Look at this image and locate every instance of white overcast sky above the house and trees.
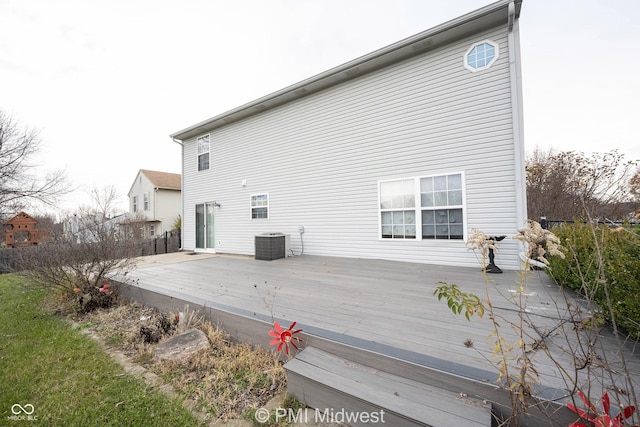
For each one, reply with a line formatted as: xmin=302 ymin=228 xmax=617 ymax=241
xmin=0 ymin=0 xmax=640 ymax=214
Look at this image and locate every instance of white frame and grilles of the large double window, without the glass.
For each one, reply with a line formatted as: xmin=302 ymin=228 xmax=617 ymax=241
xmin=378 ymin=171 xmax=468 ymax=243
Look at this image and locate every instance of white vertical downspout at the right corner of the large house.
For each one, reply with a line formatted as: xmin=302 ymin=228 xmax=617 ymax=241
xmin=507 ymin=1 xmax=527 ymax=264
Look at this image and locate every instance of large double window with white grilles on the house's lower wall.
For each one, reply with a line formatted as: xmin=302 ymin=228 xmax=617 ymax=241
xmin=379 ymin=173 xmax=464 ymax=240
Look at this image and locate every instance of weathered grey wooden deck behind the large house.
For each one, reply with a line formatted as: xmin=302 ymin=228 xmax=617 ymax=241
xmin=119 ymin=253 xmax=640 ymax=425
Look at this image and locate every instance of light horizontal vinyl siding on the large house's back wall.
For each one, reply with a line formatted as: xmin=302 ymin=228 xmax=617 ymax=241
xmin=183 ymin=24 xmax=521 ymax=268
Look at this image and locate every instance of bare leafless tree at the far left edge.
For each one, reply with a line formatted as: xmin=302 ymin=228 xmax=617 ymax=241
xmin=0 ymin=110 xmax=70 ymax=216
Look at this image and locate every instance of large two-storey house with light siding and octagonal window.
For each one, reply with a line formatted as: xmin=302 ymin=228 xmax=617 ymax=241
xmin=171 ymin=1 xmax=526 ymax=269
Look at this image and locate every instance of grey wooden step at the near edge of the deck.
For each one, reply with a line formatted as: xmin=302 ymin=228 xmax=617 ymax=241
xmin=284 ymin=347 xmax=491 ymax=427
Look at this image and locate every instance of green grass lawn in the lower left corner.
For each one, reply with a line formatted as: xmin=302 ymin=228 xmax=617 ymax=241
xmin=0 ymin=274 xmax=200 ymax=427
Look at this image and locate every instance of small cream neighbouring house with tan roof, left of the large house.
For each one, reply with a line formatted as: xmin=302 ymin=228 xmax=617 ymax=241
xmin=128 ymin=169 xmax=182 ymax=237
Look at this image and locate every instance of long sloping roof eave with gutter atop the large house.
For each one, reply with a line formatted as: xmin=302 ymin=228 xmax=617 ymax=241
xmin=170 ymin=0 xmax=522 ymax=141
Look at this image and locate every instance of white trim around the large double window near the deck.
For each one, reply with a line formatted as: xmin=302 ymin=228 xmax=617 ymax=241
xmin=378 ymin=171 xmax=469 ymax=244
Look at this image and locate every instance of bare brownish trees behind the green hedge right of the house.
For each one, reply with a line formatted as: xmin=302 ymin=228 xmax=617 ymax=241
xmin=526 ymin=149 xmax=638 ymax=219
